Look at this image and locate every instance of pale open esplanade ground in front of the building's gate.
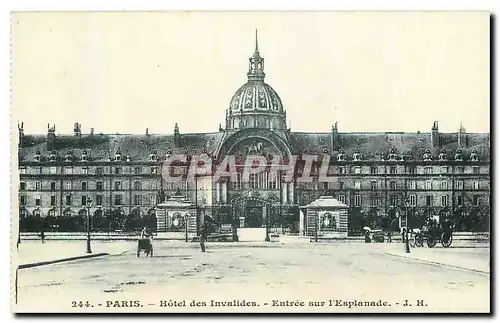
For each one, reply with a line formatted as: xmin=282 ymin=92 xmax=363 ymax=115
xmin=13 ymin=241 xmax=490 ymax=312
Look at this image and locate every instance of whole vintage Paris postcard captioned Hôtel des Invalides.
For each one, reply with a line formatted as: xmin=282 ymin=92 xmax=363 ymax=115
xmin=11 ymin=11 xmax=491 ymax=313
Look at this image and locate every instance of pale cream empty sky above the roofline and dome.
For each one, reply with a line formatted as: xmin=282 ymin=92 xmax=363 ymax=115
xmin=11 ymin=11 xmax=490 ymax=134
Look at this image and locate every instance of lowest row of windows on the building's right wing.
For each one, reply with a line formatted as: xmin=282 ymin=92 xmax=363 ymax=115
xmin=337 ymin=195 xmax=481 ymax=207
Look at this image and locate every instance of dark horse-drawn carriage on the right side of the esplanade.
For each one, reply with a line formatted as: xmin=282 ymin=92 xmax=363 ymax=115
xmin=409 ymin=221 xmax=453 ymax=248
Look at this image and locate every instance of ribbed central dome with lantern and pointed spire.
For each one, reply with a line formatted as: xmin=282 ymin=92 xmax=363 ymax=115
xmin=226 ymin=32 xmax=286 ymax=130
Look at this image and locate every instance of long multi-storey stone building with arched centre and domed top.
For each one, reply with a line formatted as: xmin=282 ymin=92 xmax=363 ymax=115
xmin=18 ymin=33 xmax=491 ymax=233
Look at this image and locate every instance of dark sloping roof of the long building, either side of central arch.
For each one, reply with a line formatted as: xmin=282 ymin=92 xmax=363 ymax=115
xmin=19 ymin=132 xmax=490 ymax=161
